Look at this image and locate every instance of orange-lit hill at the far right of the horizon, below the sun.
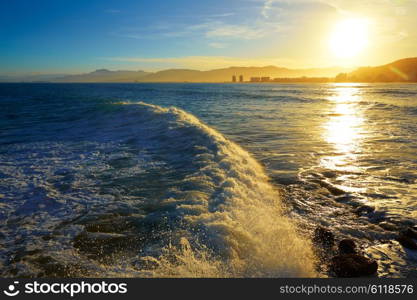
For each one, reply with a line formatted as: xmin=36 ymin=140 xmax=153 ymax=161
xmin=335 ymin=57 xmax=417 ymax=82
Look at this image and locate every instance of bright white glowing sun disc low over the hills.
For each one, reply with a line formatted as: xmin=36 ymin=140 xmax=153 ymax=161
xmin=329 ymin=19 xmax=369 ymax=58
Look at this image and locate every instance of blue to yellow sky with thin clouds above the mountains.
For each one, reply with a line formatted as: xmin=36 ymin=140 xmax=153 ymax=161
xmin=0 ymin=0 xmax=417 ymax=74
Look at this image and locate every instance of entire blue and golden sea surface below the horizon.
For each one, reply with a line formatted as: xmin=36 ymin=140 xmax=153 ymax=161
xmin=0 ymin=83 xmax=417 ymax=277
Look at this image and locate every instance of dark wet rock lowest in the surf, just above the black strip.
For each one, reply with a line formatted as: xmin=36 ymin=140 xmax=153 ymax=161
xmin=330 ymin=254 xmax=378 ymax=277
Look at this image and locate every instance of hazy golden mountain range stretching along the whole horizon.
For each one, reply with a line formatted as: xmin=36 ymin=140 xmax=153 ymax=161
xmin=0 ymin=57 xmax=417 ymax=83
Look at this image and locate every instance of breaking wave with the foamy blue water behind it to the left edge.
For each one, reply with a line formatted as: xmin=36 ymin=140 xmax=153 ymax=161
xmin=0 ymin=102 xmax=316 ymax=277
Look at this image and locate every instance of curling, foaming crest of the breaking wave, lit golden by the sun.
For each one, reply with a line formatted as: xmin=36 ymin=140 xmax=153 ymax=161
xmin=99 ymin=102 xmax=314 ymax=277
